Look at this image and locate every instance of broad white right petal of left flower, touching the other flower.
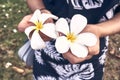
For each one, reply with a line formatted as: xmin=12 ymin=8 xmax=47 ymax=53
xmin=40 ymin=23 xmax=57 ymax=38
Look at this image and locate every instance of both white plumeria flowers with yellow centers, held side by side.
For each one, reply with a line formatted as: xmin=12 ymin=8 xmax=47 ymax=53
xmin=25 ymin=10 xmax=97 ymax=57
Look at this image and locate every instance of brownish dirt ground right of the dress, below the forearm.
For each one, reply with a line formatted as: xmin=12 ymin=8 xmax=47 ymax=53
xmin=104 ymin=34 xmax=120 ymax=80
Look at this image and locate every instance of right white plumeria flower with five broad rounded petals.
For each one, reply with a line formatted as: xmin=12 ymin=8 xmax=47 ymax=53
xmin=55 ymin=14 xmax=97 ymax=58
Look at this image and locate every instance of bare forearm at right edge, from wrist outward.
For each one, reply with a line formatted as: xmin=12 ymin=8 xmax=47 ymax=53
xmin=97 ymin=13 xmax=120 ymax=36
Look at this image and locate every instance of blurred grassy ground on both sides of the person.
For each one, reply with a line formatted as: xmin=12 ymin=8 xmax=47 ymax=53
xmin=0 ymin=0 xmax=120 ymax=80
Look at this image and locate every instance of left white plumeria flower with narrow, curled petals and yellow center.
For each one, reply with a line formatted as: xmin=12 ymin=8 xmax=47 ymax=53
xmin=25 ymin=9 xmax=58 ymax=49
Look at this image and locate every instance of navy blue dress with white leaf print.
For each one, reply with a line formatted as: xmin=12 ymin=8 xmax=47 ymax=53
xmin=33 ymin=0 xmax=120 ymax=80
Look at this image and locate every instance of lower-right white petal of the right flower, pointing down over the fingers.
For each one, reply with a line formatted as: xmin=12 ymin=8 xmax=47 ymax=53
xmin=70 ymin=43 xmax=88 ymax=58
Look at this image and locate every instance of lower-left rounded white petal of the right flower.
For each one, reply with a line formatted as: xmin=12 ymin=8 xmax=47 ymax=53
xmin=55 ymin=36 xmax=69 ymax=53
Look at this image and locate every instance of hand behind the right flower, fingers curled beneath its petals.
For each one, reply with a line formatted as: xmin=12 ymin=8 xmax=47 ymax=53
xmin=63 ymin=25 xmax=100 ymax=64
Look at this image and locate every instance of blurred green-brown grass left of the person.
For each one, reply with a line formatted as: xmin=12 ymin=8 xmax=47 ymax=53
xmin=0 ymin=0 xmax=32 ymax=80
